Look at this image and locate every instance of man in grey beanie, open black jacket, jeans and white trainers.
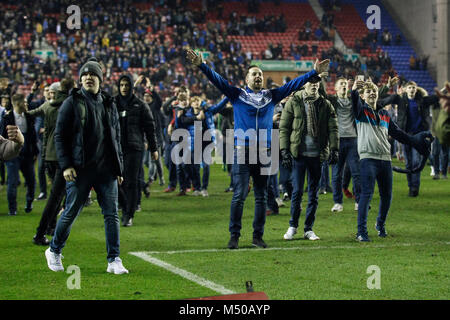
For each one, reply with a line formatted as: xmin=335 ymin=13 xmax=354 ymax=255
xmin=45 ymin=59 xmax=128 ymax=274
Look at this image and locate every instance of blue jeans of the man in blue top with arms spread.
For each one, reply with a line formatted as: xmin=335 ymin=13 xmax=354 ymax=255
xmin=229 ymin=152 xmax=270 ymax=238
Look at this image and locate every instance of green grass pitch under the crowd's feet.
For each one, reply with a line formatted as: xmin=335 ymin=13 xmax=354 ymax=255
xmin=0 ymin=163 xmax=450 ymax=300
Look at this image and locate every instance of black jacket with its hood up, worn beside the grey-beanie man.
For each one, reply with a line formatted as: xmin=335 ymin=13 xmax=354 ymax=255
xmin=114 ymin=75 xmax=158 ymax=152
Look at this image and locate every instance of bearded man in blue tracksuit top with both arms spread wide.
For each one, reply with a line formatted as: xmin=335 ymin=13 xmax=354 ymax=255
xmin=187 ymin=49 xmax=330 ymax=249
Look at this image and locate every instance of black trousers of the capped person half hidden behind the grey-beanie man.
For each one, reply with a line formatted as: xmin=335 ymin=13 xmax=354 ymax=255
xmin=36 ymin=161 xmax=66 ymax=237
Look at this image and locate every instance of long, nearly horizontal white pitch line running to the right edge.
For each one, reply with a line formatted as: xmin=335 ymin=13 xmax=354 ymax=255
xmin=135 ymin=242 xmax=450 ymax=254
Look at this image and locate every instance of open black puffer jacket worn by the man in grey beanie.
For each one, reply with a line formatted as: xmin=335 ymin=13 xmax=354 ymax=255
xmin=55 ymin=89 xmax=123 ymax=176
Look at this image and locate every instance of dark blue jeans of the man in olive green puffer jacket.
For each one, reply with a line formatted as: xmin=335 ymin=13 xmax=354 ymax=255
xmin=289 ymin=156 xmax=322 ymax=232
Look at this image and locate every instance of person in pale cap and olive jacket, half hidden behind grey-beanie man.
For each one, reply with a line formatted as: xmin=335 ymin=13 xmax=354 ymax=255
xmin=28 ymin=79 xmax=74 ymax=245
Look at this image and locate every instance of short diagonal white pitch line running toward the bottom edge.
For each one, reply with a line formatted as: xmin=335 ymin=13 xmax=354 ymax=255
xmin=130 ymin=252 xmax=235 ymax=294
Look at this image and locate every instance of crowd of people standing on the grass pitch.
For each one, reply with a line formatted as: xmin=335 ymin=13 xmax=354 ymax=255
xmin=0 ymin=50 xmax=448 ymax=273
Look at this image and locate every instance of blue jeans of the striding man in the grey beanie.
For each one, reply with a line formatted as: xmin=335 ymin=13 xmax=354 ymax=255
xmin=50 ymin=169 xmax=120 ymax=262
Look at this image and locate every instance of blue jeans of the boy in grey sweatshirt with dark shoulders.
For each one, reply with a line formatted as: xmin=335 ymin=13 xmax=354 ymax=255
xmin=358 ymin=159 xmax=392 ymax=234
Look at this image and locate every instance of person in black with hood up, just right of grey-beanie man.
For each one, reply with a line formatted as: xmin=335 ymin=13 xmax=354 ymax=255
xmin=114 ymin=75 xmax=158 ymax=227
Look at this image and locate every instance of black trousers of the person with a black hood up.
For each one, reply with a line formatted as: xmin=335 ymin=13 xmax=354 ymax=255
xmin=120 ymin=151 xmax=143 ymax=218
